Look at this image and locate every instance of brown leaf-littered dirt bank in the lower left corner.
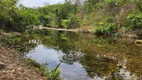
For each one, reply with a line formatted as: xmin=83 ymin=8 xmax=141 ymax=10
xmin=0 ymin=45 xmax=46 ymax=80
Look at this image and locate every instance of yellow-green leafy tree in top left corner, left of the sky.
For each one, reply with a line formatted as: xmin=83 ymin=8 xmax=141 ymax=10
xmin=0 ymin=0 xmax=18 ymax=28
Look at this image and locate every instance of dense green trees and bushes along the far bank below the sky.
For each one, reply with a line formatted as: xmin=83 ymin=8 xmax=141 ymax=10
xmin=0 ymin=0 xmax=142 ymax=35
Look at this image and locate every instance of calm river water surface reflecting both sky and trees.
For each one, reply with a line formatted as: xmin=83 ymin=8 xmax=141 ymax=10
xmin=26 ymin=31 xmax=142 ymax=80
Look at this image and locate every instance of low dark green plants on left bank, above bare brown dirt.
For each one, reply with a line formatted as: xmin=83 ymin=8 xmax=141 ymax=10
xmin=0 ymin=34 xmax=36 ymax=52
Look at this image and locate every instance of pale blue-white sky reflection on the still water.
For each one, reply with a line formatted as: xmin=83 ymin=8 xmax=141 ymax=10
xmin=27 ymin=45 xmax=86 ymax=80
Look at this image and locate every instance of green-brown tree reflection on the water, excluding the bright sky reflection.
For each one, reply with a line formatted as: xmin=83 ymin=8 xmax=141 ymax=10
xmin=24 ymin=31 xmax=142 ymax=80
